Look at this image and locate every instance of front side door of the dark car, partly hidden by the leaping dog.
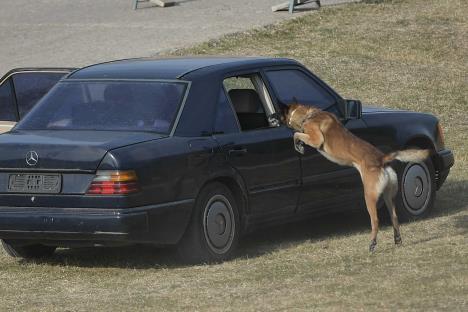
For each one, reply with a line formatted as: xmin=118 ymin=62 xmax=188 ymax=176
xmin=265 ymin=67 xmax=365 ymax=213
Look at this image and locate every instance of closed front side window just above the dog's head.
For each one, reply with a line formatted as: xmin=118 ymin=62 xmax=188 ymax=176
xmin=266 ymin=69 xmax=335 ymax=108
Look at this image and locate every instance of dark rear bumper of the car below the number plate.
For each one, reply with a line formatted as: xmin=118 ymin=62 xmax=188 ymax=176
xmin=0 ymin=200 xmax=194 ymax=246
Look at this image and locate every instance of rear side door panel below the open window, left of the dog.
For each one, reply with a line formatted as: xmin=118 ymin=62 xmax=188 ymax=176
xmin=216 ymin=127 xmax=301 ymax=215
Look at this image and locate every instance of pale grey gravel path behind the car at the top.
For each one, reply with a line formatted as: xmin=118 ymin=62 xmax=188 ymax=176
xmin=0 ymin=0 xmax=360 ymax=76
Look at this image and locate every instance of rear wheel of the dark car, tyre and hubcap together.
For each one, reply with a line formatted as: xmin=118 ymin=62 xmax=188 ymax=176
xmin=177 ymin=182 xmax=240 ymax=263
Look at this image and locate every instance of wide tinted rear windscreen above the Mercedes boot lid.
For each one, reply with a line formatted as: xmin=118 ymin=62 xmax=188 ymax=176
xmin=16 ymin=80 xmax=187 ymax=133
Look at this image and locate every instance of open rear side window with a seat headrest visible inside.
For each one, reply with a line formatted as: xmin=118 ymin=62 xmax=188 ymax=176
xmin=223 ymin=74 xmax=273 ymax=131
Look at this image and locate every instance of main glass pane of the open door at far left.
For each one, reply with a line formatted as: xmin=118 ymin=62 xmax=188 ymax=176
xmin=12 ymin=72 xmax=66 ymax=119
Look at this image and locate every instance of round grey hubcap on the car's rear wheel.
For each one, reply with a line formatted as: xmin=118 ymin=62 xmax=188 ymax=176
xmin=203 ymin=195 xmax=236 ymax=254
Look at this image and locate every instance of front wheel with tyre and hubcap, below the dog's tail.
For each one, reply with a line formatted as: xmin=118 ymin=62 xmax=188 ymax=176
xmin=395 ymin=159 xmax=436 ymax=222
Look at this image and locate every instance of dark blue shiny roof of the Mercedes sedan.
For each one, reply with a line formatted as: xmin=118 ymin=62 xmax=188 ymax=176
xmin=67 ymin=57 xmax=298 ymax=79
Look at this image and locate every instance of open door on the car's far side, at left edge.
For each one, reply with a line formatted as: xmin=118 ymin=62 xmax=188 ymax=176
xmin=0 ymin=68 xmax=75 ymax=133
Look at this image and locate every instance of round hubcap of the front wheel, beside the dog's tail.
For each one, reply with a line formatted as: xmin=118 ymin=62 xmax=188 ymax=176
xmin=402 ymin=163 xmax=432 ymax=215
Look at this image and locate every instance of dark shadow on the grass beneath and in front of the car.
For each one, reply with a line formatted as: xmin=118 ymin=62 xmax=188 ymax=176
xmin=20 ymin=181 xmax=468 ymax=269
